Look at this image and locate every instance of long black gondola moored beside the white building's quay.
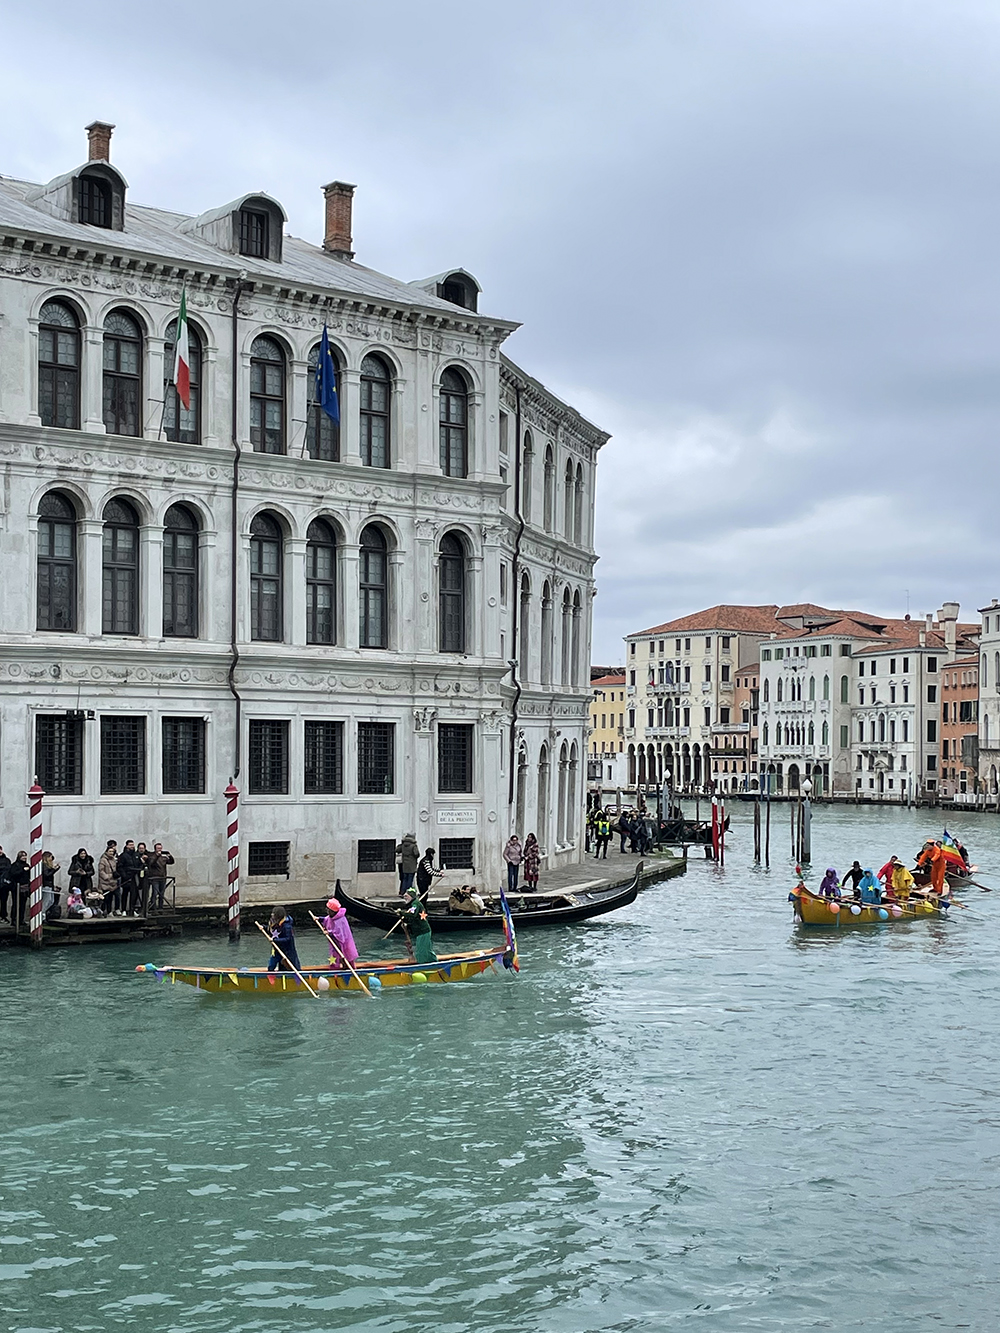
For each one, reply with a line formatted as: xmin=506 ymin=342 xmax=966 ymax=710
xmin=337 ymin=861 xmax=643 ymax=933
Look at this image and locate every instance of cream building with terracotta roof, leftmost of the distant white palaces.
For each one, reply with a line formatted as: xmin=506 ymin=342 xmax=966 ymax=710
xmin=624 ymin=605 xmax=779 ymax=790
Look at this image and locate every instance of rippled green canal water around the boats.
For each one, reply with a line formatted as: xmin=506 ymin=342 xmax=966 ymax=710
xmin=0 ymin=805 xmax=1000 ymax=1333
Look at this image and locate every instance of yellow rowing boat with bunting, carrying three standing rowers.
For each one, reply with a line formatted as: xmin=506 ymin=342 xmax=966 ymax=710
xmin=136 ymin=944 xmax=513 ymax=996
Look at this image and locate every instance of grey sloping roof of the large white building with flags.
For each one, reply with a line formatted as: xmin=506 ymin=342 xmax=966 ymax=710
xmin=0 ymin=173 xmax=517 ymax=329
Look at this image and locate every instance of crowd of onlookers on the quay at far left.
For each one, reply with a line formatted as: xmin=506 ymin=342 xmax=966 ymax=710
xmin=0 ymin=838 xmax=173 ymax=924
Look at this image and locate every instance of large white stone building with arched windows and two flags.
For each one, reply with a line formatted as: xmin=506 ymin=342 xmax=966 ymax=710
xmin=0 ymin=124 xmax=607 ymax=901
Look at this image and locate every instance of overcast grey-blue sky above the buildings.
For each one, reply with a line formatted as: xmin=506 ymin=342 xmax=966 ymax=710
xmin=0 ymin=0 xmax=1000 ymax=664
